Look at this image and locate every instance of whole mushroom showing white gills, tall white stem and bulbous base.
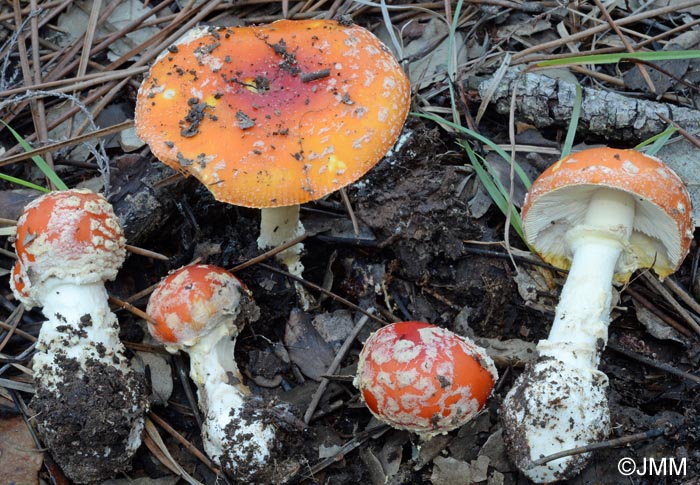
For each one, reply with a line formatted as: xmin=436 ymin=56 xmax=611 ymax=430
xmin=501 ymin=148 xmax=693 ymax=483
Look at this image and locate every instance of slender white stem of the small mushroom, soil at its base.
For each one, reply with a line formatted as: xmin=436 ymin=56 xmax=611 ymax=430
xmin=184 ymin=325 xmax=276 ymax=472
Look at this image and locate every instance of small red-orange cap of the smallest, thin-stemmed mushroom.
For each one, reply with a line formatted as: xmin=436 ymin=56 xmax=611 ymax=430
xmin=146 ymin=264 xmax=248 ymax=345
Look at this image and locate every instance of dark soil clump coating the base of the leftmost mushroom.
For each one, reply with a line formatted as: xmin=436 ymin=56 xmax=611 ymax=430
xmin=30 ymin=358 xmax=145 ymax=483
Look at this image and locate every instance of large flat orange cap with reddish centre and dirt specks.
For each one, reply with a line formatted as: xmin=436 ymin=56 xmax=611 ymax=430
xmin=135 ymin=20 xmax=410 ymax=208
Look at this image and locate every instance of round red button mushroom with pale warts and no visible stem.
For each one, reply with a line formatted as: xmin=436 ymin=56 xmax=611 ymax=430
xmin=355 ymin=322 xmax=498 ymax=438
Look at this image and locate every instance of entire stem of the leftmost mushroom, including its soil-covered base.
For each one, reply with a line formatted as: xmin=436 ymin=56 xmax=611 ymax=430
xmin=31 ymin=278 xmax=146 ymax=483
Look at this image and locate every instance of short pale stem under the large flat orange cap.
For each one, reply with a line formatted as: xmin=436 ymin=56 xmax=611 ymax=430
xmin=258 ymin=204 xmax=304 ymax=277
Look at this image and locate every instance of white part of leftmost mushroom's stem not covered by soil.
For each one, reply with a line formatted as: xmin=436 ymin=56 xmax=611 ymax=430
xmin=32 ymin=278 xmax=144 ymax=454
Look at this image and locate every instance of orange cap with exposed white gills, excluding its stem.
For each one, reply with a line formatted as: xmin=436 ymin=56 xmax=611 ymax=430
xmin=522 ymin=148 xmax=694 ymax=283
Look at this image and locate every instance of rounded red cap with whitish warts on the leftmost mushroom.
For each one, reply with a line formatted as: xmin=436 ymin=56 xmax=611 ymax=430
xmin=13 ymin=189 xmax=126 ymax=297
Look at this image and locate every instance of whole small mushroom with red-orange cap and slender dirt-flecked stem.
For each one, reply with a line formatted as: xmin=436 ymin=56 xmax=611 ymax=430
xmin=146 ymin=265 xmax=288 ymax=483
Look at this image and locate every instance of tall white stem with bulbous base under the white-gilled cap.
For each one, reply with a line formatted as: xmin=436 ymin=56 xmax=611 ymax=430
xmin=502 ymin=189 xmax=634 ymax=483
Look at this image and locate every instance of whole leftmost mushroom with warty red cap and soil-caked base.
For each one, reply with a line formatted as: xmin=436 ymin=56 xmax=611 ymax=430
xmin=10 ymin=190 xmax=146 ymax=483
